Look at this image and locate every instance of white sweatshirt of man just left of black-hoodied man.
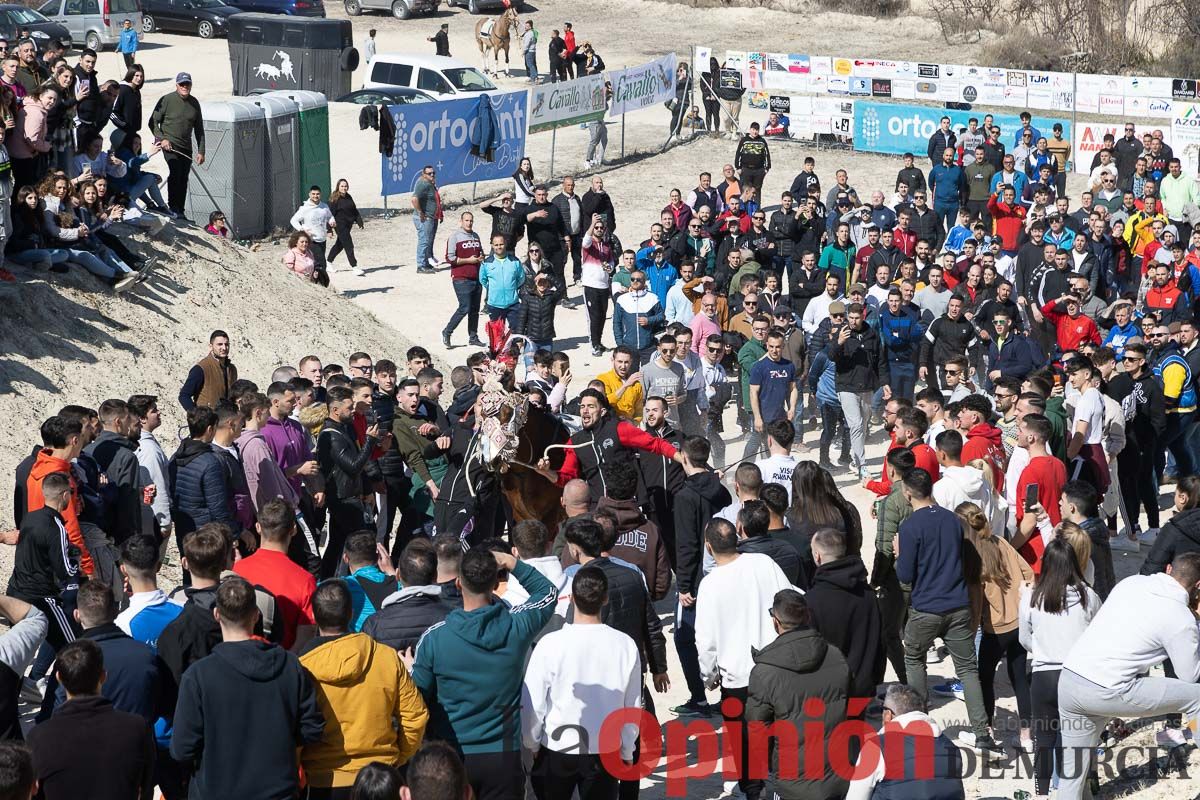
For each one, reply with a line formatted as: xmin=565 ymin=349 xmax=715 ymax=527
xmin=696 ymin=553 xmax=792 ymax=688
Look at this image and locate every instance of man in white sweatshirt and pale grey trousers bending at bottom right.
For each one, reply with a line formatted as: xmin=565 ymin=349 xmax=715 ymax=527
xmin=1058 ymin=553 xmax=1200 ymax=800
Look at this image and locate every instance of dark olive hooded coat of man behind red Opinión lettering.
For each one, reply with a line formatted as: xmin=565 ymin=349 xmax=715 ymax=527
xmin=745 ymin=628 xmax=850 ymax=798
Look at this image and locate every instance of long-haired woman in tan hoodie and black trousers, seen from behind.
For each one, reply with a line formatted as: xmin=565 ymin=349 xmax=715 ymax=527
xmin=954 ymin=503 xmax=1033 ymax=751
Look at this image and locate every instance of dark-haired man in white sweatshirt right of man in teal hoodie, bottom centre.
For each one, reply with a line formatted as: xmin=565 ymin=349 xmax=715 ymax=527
xmin=521 ymin=566 xmax=642 ymax=798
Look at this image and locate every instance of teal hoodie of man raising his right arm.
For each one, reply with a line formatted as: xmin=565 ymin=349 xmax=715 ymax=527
xmin=413 ymin=561 xmax=558 ymax=753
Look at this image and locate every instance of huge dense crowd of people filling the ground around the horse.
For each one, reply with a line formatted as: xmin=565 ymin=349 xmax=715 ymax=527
xmin=7 ymin=23 xmax=1200 ymax=800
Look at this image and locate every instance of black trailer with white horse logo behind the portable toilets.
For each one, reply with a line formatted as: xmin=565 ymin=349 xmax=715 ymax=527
xmin=229 ymin=13 xmax=359 ymax=100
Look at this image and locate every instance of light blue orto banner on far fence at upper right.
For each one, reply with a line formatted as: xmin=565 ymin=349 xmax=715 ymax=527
xmin=854 ymin=100 xmax=1074 ymax=155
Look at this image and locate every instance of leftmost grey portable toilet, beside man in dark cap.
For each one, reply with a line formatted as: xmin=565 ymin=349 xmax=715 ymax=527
xmin=186 ymin=98 xmax=270 ymax=239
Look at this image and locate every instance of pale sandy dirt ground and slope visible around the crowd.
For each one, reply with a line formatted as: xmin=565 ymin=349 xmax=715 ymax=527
xmin=0 ymin=0 xmax=1200 ymax=800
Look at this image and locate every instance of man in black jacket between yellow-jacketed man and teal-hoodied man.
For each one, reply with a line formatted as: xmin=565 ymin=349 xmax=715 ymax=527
xmin=362 ymin=541 xmax=455 ymax=652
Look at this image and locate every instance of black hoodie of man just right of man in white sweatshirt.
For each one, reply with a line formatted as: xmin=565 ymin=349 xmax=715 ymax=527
xmin=804 ymin=553 xmax=887 ymax=697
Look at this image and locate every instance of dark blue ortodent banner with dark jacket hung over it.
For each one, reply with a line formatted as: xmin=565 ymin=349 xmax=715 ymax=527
xmin=382 ymin=91 xmax=528 ymax=196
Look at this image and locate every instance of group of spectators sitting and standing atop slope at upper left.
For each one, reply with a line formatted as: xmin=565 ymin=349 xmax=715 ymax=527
xmin=0 ymin=34 xmax=204 ymax=293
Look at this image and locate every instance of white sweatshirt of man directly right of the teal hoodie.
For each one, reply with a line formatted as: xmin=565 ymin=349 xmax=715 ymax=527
xmin=521 ymin=625 xmax=642 ymax=760
